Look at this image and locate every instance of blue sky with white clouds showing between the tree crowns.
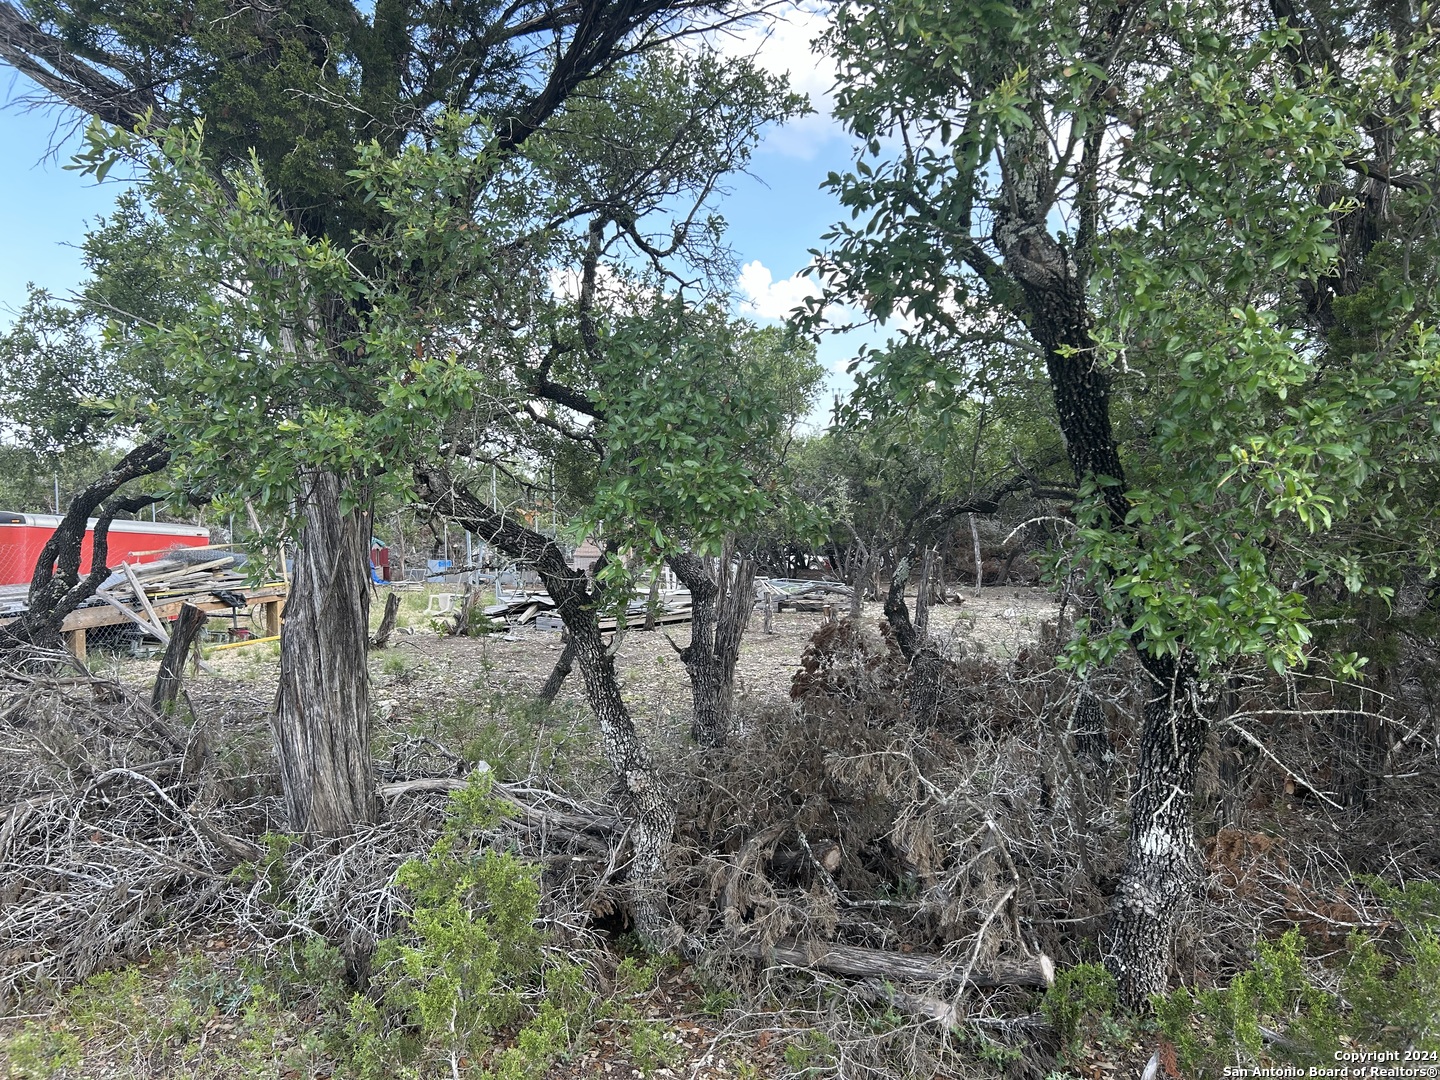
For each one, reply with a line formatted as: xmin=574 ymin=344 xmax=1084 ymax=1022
xmin=0 ymin=7 xmax=858 ymax=402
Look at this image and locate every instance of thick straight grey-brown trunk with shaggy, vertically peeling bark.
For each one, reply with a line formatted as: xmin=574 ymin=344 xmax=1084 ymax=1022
xmin=272 ymin=469 xmax=376 ymax=837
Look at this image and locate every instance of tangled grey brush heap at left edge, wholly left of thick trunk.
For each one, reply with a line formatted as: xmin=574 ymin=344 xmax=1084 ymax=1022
xmin=0 ymin=654 xmax=264 ymax=1008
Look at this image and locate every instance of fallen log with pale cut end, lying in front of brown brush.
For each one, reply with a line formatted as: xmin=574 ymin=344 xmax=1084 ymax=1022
xmin=739 ymin=939 xmax=1056 ymax=989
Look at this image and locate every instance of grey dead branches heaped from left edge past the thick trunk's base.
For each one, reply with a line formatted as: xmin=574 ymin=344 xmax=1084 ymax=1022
xmin=0 ymin=654 xmax=621 ymax=1015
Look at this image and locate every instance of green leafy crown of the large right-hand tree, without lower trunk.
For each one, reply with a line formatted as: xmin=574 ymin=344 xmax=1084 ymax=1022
xmin=811 ymin=0 xmax=1440 ymax=677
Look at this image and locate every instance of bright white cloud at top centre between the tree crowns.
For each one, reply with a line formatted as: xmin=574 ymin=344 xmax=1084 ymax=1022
xmin=713 ymin=0 xmax=845 ymax=160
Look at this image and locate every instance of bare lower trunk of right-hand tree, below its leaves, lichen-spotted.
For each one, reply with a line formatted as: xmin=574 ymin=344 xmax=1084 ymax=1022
xmin=1104 ymin=655 xmax=1208 ymax=1008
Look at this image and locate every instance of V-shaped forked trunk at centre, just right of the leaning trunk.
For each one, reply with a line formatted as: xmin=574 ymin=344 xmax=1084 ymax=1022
xmin=667 ymin=546 xmax=755 ymax=747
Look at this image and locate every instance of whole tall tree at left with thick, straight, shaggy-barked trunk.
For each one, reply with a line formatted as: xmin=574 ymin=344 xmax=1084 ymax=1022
xmin=0 ymin=0 xmax=793 ymax=835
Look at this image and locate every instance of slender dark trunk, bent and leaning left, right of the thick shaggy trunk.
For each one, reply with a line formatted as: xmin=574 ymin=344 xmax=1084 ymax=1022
xmin=415 ymin=468 xmax=675 ymax=949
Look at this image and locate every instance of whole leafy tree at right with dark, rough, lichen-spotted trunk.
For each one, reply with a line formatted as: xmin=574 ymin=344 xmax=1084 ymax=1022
xmin=821 ymin=0 xmax=1434 ymax=1004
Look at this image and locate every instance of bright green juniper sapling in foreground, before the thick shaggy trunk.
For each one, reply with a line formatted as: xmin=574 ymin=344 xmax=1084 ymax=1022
xmin=348 ymin=773 xmax=580 ymax=1080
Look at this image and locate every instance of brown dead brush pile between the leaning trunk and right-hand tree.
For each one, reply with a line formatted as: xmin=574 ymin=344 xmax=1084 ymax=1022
xmin=677 ymin=621 xmax=1129 ymax=1025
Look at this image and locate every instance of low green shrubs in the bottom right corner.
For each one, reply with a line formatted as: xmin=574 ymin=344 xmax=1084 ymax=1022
xmin=1153 ymin=881 xmax=1440 ymax=1077
